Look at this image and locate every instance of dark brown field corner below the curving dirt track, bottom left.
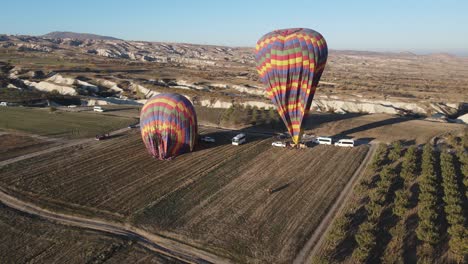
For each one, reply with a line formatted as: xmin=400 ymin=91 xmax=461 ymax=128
xmin=0 ymin=205 xmax=182 ymax=263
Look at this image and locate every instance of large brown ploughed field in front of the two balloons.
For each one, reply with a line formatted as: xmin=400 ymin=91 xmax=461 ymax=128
xmin=0 ymin=130 xmax=368 ymax=263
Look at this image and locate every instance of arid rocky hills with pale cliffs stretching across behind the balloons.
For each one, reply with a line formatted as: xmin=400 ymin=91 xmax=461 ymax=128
xmin=0 ymin=34 xmax=468 ymax=121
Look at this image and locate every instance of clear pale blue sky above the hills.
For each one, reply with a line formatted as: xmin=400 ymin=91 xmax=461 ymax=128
xmin=0 ymin=0 xmax=468 ymax=54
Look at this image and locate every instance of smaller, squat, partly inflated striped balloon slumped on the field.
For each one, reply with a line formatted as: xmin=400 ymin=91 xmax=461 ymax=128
xmin=140 ymin=93 xmax=198 ymax=160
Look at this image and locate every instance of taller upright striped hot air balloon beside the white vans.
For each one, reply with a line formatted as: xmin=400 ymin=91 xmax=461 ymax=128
xmin=255 ymin=28 xmax=328 ymax=144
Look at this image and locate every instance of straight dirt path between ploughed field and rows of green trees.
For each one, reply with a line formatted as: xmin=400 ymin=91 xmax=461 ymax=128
xmin=293 ymin=144 xmax=377 ymax=264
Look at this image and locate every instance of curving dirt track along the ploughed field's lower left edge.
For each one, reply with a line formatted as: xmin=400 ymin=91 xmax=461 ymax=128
xmin=0 ymin=189 xmax=229 ymax=263
